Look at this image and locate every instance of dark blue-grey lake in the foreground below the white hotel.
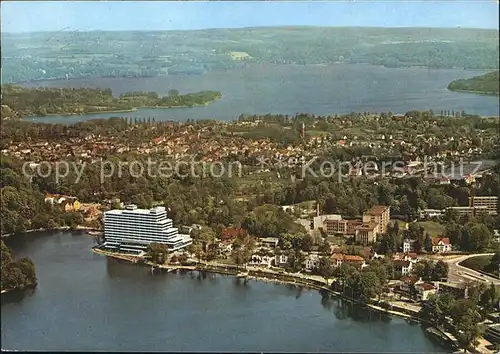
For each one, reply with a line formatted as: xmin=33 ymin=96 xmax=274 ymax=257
xmin=1 ymin=232 xmax=446 ymax=353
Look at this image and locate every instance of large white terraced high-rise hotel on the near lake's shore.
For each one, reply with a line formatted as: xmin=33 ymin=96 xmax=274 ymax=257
xmin=103 ymin=205 xmax=192 ymax=253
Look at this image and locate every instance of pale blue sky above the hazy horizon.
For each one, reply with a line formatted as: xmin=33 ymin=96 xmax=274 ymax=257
xmin=0 ymin=0 xmax=499 ymax=33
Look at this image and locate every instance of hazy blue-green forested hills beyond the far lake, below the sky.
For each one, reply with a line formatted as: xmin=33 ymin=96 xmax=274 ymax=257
xmin=2 ymin=27 xmax=499 ymax=83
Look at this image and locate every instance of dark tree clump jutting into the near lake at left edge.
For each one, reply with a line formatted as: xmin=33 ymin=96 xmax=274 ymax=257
xmin=1 ymin=241 xmax=37 ymax=291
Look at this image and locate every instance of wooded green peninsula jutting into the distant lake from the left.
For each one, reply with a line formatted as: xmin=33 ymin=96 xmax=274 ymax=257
xmin=2 ymin=84 xmax=222 ymax=118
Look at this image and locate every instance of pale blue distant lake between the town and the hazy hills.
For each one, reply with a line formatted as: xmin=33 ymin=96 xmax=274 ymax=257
xmin=21 ymin=64 xmax=499 ymax=123
